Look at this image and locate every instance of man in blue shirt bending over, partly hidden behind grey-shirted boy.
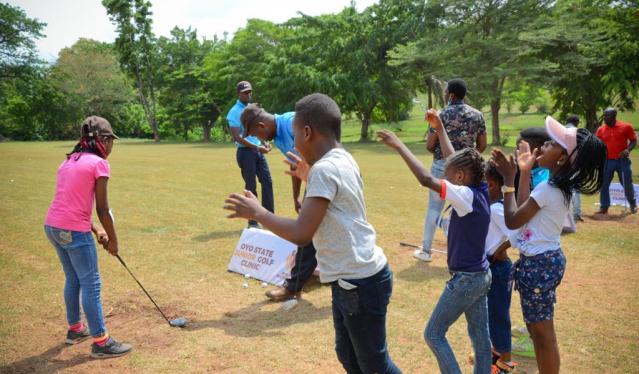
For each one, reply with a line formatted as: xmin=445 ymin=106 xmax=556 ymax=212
xmin=240 ymin=104 xmax=317 ymax=301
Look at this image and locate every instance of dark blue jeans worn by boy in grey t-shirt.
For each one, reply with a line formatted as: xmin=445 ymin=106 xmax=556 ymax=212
xmin=331 ymin=265 xmax=401 ymax=374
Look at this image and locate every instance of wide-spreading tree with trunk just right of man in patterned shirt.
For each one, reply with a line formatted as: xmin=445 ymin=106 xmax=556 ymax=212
xmin=394 ymin=0 xmax=552 ymax=144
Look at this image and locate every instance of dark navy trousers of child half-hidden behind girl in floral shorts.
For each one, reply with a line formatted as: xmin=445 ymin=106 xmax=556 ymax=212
xmin=488 ymin=260 xmax=513 ymax=353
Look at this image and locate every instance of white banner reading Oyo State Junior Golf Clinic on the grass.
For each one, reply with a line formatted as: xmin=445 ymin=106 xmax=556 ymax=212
xmin=228 ymin=228 xmax=297 ymax=286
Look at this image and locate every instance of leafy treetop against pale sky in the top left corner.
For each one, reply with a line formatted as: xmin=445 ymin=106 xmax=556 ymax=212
xmin=0 ymin=3 xmax=46 ymax=80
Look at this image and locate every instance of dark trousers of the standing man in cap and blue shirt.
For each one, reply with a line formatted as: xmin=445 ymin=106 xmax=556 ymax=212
xmin=236 ymin=147 xmax=275 ymax=224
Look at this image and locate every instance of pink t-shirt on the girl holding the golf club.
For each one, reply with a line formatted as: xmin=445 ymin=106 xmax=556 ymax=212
xmin=44 ymin=153 xmax=111 ymax=232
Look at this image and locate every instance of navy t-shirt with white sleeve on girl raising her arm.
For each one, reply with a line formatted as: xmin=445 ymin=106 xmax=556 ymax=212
xmin=441 ymin=179 xmax=490 ymax=273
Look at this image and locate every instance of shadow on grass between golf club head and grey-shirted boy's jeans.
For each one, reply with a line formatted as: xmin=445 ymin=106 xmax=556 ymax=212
xmin=185 ymin=299 xmax=333 ymax=338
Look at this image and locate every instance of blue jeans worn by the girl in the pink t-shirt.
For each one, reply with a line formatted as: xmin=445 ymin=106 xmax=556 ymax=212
xmin=44 ymin=225 xmax=106 ymax=337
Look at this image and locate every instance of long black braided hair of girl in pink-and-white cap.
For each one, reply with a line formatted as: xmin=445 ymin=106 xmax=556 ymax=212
xmin=548 ymin=128 xmax=608 ymax=204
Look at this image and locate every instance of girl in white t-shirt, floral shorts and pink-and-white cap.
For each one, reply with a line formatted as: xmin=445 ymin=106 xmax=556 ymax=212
xmin=491 ymin=116 xmax=606 ymax=374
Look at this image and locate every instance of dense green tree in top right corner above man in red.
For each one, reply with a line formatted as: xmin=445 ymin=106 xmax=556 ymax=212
xmin=521 ymin=0 xmax=639 ymax=131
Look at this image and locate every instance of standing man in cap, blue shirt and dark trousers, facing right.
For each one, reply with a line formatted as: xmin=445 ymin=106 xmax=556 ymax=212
xmin=226 ymin=81 xmax=275 ymax=227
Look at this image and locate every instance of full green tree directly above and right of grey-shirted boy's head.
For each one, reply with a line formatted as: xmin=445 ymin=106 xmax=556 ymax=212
xmin=289 ymin=0 xmax=421 ymax=141
